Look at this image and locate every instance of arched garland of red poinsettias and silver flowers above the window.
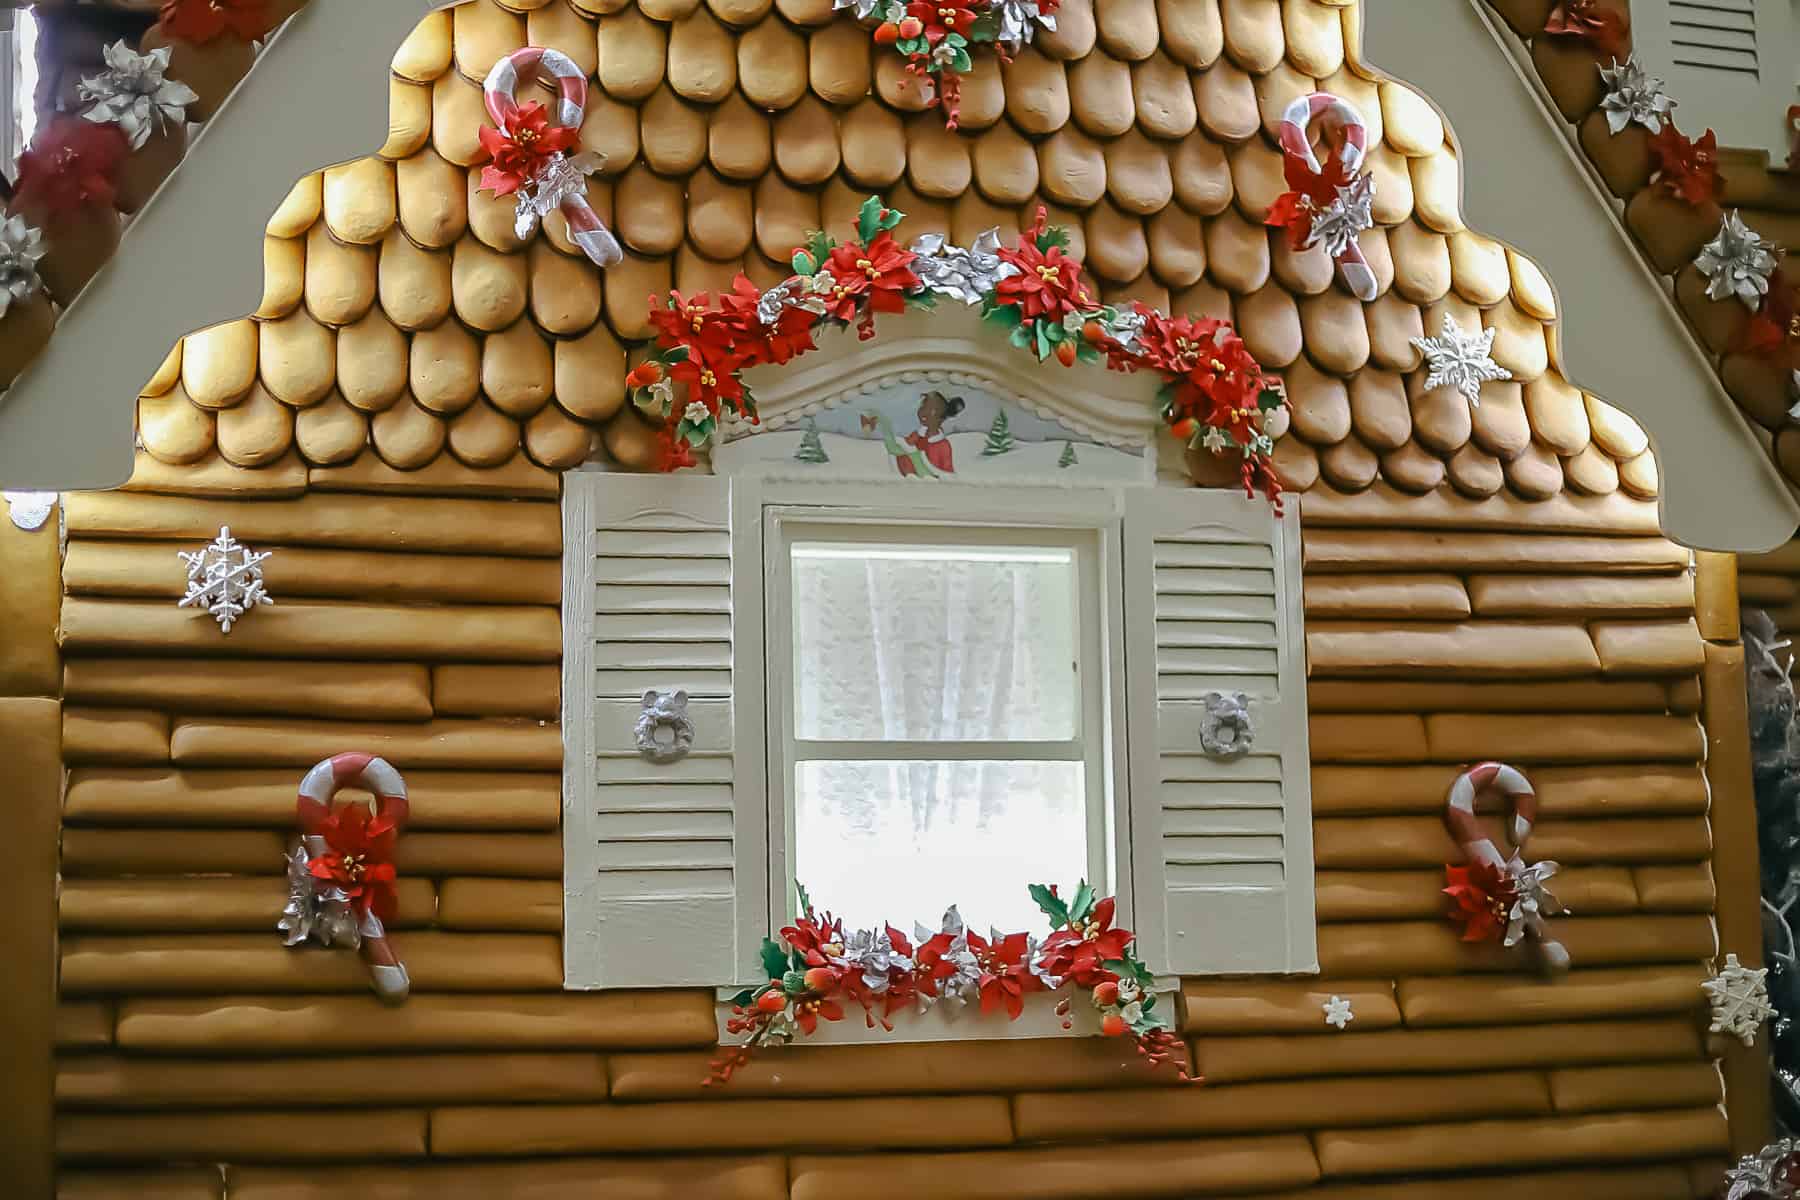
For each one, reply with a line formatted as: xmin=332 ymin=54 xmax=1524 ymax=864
xmin=626 ymin=196 xmax=1287 ymax=511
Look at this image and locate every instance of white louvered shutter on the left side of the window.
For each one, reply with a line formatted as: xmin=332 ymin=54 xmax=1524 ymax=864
xmin=563 ymin=471 xmax=763 ymax=988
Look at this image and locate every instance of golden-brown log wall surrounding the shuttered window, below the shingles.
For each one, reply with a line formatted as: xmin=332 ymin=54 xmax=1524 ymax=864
xmin=49 ymin=464 xmax=1726 ymax=1200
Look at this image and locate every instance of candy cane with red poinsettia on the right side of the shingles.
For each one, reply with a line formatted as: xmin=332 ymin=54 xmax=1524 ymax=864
xmin=1269 ymin=92 xmax=1377 ymax=300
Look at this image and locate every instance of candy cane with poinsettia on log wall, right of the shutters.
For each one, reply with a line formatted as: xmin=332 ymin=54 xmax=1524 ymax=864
xmin=1444 ymin=763 xmax=1570 ymax=973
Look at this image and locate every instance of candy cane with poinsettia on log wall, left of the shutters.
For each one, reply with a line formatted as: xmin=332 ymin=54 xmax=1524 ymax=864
xmin=281 ymin=754 xmax=412 ymax=1002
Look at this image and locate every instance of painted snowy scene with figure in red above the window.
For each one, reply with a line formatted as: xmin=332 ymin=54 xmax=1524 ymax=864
xmin=713 ymin=380 xmax=1150 ymax=484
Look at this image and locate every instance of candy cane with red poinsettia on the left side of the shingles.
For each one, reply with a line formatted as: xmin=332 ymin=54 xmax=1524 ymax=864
xmin=481 ymin=45 xmax=625 ymax=266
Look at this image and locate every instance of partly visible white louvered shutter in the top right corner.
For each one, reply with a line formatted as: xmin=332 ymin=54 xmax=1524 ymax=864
xmin=1631 ymin=0 xmax=1800 ymax=167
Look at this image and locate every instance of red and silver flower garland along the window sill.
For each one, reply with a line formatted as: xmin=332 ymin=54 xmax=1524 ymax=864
xmin=706 ymin=880 xmax=1199 ymax=1085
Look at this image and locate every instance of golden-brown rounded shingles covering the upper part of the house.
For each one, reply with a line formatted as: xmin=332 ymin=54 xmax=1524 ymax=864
xmin=108 ymin=0 xmax=1684 ymax=500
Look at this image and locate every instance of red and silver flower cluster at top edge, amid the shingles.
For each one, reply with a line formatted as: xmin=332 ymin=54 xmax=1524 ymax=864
xmin=832 ymin=0 xmax=1062 ymax=130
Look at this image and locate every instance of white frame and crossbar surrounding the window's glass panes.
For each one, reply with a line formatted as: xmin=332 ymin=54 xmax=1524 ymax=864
xmin=740 ymin=482 xmax=1132 ymax=936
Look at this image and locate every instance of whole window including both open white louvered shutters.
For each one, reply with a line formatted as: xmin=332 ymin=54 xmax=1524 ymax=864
xmin=563 ymin=471 xmax=1318 ymax=988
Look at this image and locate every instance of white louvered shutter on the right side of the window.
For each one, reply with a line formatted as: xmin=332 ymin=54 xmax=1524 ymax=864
xmin=1125 ymin=488 xmax=1318 ymax=975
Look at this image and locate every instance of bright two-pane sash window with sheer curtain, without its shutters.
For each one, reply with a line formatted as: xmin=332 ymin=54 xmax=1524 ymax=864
xmin=765 ymin=507 xmax=1116 ymax=928
